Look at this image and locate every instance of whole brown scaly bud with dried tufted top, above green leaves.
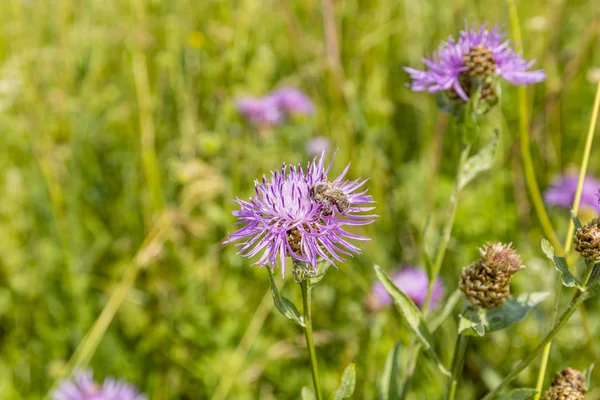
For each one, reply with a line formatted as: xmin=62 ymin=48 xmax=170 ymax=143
xmin=458 ymin=243 xmax=523 ymax=309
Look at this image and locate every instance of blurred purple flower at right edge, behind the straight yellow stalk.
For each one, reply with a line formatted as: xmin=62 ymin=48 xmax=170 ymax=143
xmin=544 ymin=175 xmax=600 ymax=213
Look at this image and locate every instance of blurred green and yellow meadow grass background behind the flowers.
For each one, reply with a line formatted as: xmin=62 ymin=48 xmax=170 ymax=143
xmin=0 ymin=0 xmax=600 ymax=400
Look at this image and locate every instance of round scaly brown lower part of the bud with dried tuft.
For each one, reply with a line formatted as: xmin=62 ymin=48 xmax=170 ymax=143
xmin=458 ymin=260 xmax=510 ymax=308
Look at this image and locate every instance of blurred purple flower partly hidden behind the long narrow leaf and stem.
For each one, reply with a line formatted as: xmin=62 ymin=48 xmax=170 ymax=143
xmin=367 ymin=267 xmax=444 ymax=311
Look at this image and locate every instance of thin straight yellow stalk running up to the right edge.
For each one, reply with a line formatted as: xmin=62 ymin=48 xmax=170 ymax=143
xmin=533 ymin=77 xmax=600 ymax=400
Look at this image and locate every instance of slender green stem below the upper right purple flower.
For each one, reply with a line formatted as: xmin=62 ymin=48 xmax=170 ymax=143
xmin=400 ymin=143 xmax=471 ymax=399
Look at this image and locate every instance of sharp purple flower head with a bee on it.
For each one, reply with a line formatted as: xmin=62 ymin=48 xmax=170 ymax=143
xmin=225 ymin=153 xmax=376 ymax=275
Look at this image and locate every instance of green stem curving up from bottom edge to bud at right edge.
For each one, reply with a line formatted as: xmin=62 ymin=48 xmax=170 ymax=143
xmin=481 ymin=266 xmax=593 ymax=400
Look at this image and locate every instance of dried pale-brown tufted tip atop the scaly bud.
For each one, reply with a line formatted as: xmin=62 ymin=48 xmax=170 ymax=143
xmin=479 ymin=242 xmax=523 ymax=280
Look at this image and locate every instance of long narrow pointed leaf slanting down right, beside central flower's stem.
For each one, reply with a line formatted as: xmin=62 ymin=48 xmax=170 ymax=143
xmin=375 ymin=265 xmax=450 ymax=376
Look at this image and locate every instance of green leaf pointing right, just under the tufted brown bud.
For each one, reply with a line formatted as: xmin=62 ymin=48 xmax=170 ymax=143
xmin=486 ymin=292 xmax=550 ymax=332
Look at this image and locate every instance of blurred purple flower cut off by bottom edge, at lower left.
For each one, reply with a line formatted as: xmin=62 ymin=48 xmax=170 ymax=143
xmin=52 ymin=371 xmax=147 ymax=400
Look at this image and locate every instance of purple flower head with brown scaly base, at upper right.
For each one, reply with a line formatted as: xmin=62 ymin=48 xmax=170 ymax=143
xmin=405 ymin=24 xmax=546 ymax=102
